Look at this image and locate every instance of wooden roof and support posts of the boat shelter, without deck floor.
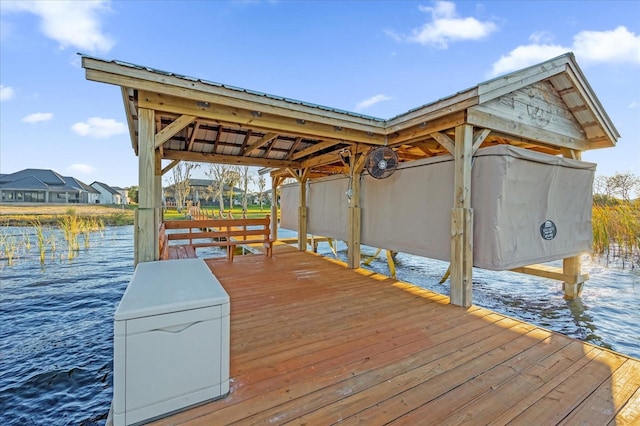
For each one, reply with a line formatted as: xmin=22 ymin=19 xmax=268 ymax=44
xmin=82 ymin=53 xmax=619 ymax=307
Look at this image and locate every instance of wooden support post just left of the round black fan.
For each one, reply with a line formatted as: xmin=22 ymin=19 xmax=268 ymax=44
xmin=347 ymin=154 xmax=366 ymax=269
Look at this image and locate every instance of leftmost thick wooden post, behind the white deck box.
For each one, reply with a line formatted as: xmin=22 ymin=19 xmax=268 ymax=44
xmin=135 ymin=108 xmax=159 ymax=262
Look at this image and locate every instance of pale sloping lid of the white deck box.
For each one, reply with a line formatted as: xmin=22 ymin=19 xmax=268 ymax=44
xmin=115 ymin=259 xmax=229 ymax=321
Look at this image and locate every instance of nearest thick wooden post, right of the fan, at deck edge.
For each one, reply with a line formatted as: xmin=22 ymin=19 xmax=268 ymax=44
xmin=451 ymin=124 xmax=473 ymax=307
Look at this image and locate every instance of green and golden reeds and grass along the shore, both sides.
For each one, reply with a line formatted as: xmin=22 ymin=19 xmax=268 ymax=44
xmin=0 ymin=198 xmax=640 ymax=269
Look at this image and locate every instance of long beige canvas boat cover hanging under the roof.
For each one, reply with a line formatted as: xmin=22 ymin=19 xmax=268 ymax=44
xmin=281 ymin=145 xmax=596 ymax=270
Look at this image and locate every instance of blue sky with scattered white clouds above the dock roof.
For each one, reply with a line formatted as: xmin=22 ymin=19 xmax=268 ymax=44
xmin=0 ymin=0 xmax=640 ymax=187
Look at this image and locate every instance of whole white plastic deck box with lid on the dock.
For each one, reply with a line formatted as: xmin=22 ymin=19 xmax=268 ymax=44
xmin=112 ymin=259 xmax=229 ymax=426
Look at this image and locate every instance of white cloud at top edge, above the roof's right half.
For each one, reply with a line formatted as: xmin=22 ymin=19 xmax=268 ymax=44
xmin=398 ymin=1 xmax=498 ymax=49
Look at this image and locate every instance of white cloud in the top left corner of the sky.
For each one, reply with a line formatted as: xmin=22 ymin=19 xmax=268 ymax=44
xmin=2 ymin=0 xmax=114 ymax=53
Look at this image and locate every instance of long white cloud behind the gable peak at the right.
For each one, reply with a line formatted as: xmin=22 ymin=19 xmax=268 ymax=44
xmin=491 ymin=27 xmax=640 ymax=76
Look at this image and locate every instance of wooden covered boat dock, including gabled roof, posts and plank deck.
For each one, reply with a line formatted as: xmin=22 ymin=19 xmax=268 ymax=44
xmin=82 ymin=54 xmax=640 ymax=425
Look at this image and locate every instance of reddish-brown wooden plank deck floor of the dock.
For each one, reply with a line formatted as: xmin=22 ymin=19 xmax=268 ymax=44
xmin=154 ymin=245 xmax=640 ymax=425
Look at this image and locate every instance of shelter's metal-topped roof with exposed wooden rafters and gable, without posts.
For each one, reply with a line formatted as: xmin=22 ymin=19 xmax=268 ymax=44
xmin=82 ymin=53 xmax=619 ymax=177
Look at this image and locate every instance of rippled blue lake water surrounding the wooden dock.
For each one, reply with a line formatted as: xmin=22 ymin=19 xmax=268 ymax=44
xmin=0 ymin=226 xmax=640 ymax=425
